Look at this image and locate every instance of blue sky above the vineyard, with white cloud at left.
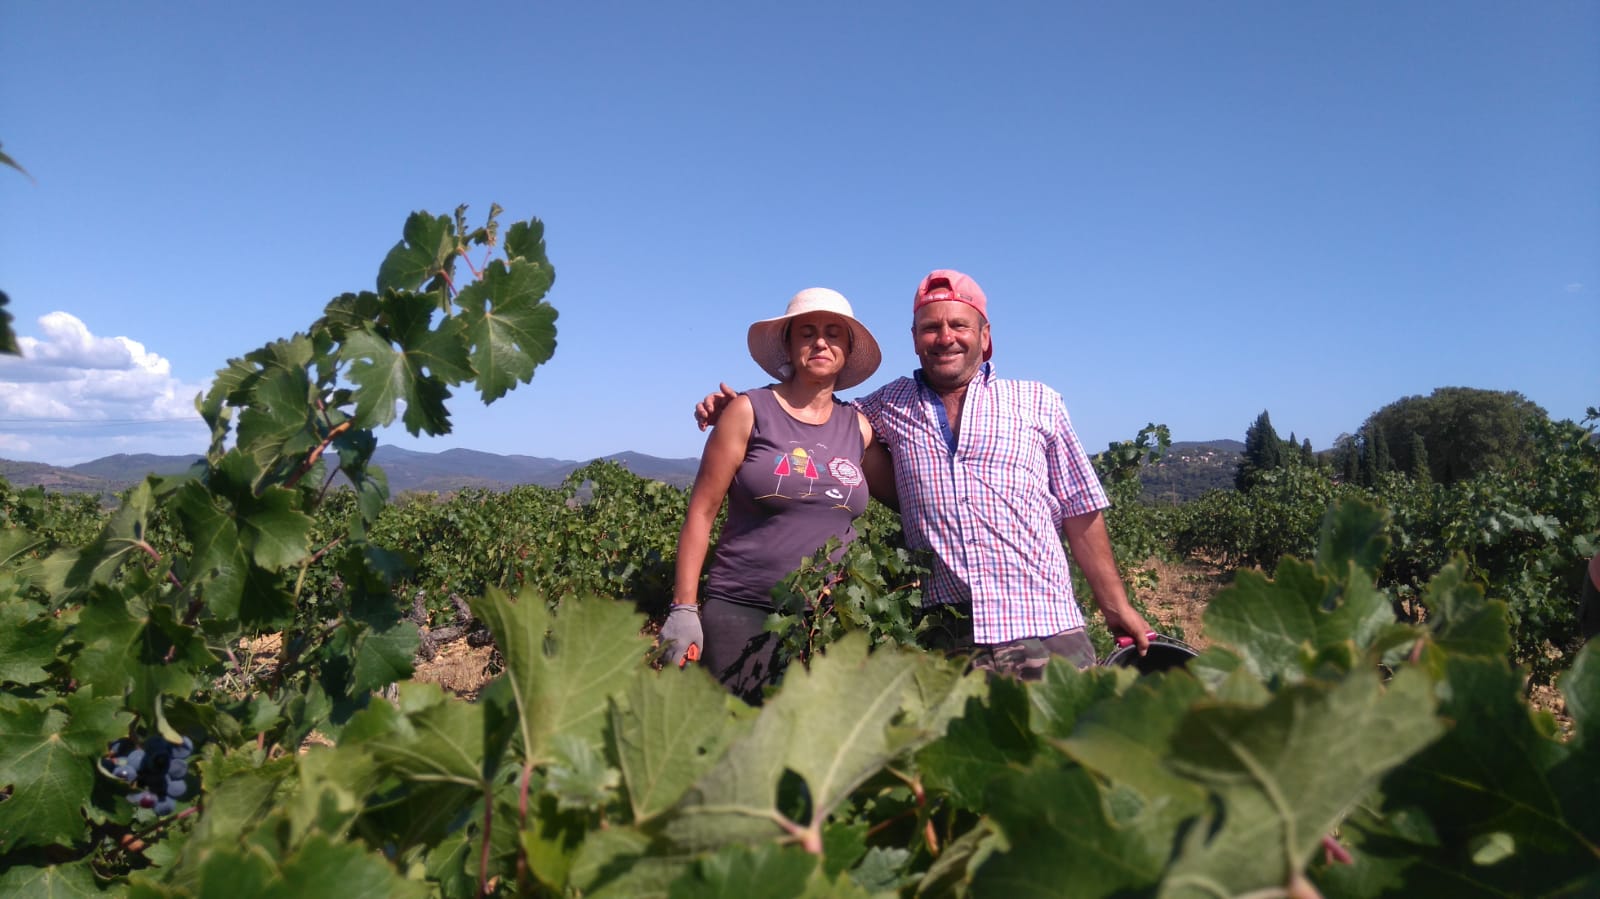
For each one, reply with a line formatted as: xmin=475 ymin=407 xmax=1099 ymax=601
xmin=0 ymin=0 xmax=1600 ymax=464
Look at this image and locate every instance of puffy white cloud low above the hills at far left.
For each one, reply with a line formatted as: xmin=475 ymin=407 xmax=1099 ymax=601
xmin=0 ymin=312 xmax=206 ymax=462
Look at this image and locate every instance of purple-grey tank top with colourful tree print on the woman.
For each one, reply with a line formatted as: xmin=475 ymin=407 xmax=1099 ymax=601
xmin=706 ymin=387 xmax=867 ymax=608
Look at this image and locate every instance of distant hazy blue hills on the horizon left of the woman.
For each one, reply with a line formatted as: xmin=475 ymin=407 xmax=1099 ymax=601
xmin=0 ymin=446 xmax=699 ymax=496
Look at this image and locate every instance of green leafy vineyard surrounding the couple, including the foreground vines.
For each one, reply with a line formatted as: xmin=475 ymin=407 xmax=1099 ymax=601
xmin=0 ymin=208 xmax=1600 ymax=899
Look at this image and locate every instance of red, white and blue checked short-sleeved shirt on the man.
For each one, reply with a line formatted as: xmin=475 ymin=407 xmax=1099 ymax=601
xmin=856 ymin=363 xmax=1110 ymax=643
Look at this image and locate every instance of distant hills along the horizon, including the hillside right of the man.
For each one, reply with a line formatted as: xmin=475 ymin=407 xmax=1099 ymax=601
xmin=0 ymin=440 xmax=1245 ymax=502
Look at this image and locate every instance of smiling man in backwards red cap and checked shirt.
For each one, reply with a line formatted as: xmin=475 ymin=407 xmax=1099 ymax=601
xmin=696 ymin=269 xmax=1149 ymax=680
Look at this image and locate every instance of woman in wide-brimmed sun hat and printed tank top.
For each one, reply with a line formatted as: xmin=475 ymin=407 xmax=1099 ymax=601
xmin=661 ymin=288 xmax=883 ymax=704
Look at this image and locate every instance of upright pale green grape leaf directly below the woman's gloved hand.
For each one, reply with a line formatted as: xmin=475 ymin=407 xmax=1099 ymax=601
xmin=611 ymin=665 xmax=752 ymax=824
